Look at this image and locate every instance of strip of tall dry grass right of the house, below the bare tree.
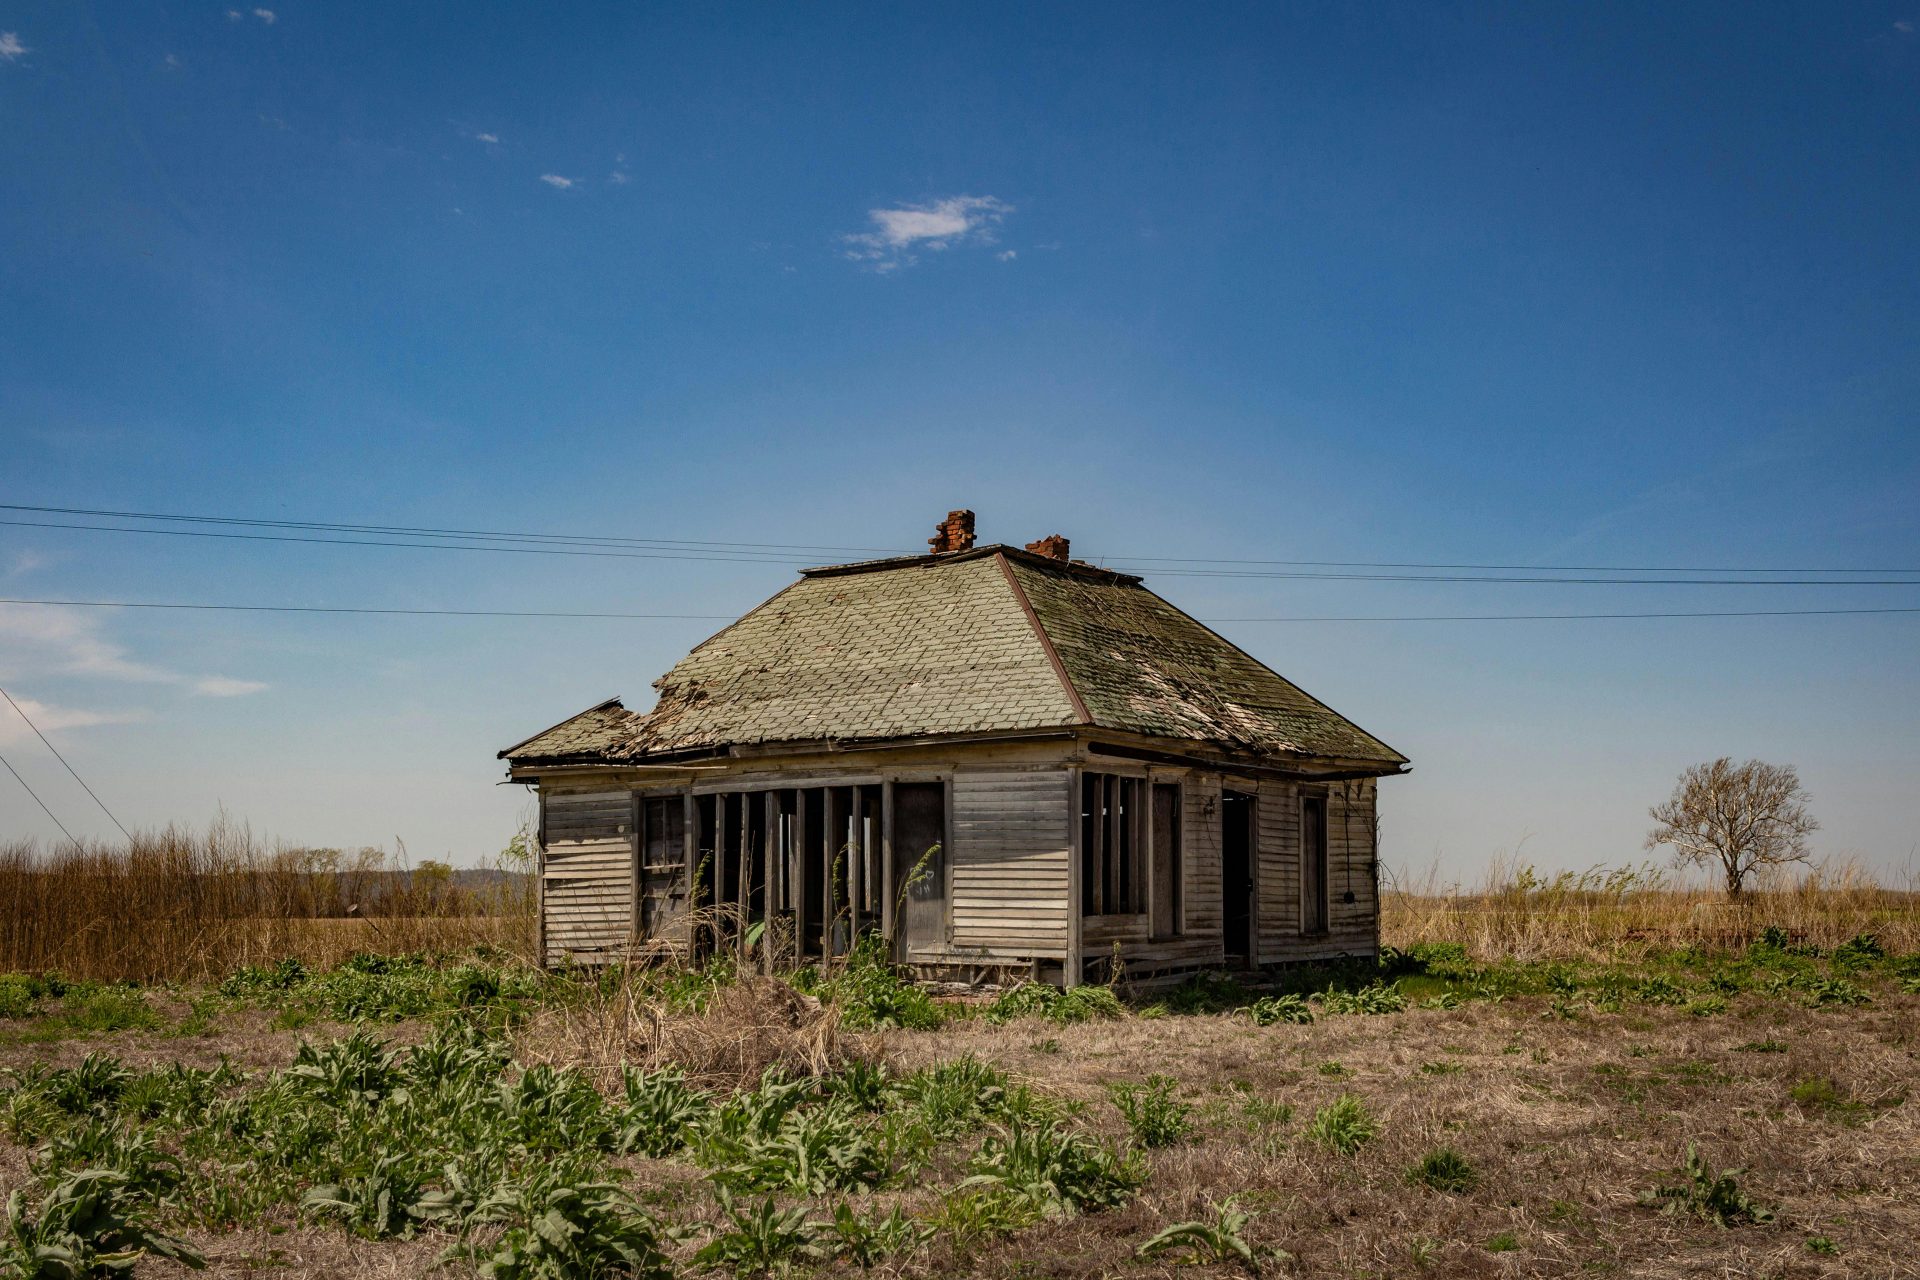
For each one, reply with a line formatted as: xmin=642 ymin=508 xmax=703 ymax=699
xmin=1380 ymin=858 xmax=1920 ymax=960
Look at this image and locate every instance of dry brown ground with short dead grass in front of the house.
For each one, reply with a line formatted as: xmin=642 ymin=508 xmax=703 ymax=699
xmin=0 ymin=996 xmax=1920 ymax=1278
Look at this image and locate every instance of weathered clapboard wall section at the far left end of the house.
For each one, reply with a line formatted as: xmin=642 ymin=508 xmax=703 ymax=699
xmin=540 ymin=787 xmax=636 ymax=963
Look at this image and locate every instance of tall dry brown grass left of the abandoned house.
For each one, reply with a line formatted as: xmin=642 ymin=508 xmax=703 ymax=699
xmin=0 ymin=821 xmax=534 ymax=983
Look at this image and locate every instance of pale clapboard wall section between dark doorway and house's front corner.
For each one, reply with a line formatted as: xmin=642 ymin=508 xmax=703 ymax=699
xmin=948 ymin=768 xmax=1075 ymax=958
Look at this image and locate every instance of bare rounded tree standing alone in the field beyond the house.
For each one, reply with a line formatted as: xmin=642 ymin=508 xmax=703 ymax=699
xmin=1647 ymin=756 xmax=1820 ymax=898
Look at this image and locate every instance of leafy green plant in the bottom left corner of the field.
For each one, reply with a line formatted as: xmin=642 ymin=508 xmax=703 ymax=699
xmin=0 ymin=1169 xmax=207 ymax=1280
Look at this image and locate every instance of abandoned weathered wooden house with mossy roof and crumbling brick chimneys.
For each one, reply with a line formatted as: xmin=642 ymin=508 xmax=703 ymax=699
xmin=499 ymin=512 xmax=1407 ymax=984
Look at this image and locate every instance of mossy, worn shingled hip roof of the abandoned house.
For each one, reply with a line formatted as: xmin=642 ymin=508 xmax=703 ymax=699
xmin=501 ymin=545 xmax=1405 ymax=770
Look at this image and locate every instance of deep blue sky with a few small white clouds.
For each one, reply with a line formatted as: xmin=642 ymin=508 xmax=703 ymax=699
xmin=0 ymin=0 xmax=1920 ymax=879
